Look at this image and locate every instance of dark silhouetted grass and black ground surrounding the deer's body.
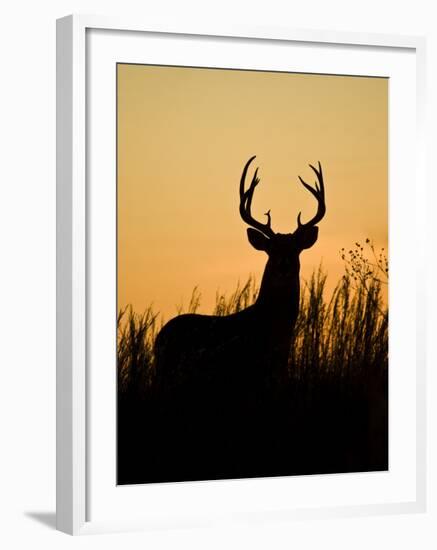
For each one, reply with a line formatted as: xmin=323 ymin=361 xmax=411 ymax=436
xmin=117 ymin=248 xmax=388 ymax=484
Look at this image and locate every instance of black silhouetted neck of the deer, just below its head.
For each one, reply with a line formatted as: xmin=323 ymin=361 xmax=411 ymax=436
xmin=255 ymin=257 xmax=300 ymax=326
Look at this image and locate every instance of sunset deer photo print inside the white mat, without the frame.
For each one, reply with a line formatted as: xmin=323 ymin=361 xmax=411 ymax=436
xmin=117 ymin=64 xmax=389 ymax=484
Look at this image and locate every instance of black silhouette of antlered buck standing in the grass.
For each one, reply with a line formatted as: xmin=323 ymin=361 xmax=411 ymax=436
xmin=155 ymin=156 xmax=326 ymax=407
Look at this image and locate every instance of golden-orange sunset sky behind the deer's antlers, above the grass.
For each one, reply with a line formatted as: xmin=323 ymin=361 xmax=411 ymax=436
xmin=117 ymin=64 xmax=388 ymax=320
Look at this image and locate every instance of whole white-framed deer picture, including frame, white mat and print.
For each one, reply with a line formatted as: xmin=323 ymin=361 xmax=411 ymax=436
xmin=57 ymin=16 xmax=426 ymax=534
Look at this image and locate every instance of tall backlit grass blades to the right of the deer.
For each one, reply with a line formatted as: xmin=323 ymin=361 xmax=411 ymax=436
xmin=289 ymin=269 xmax=388 ymax=384
